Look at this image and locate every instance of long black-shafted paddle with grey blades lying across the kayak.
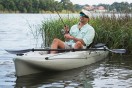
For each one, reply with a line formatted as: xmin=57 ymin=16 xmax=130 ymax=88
xmin=5 ymin=46 xmax=126 ymax=55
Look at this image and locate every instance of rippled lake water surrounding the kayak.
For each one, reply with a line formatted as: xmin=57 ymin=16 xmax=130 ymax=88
xmin=0 ymin=14 xmax=132 ymax=88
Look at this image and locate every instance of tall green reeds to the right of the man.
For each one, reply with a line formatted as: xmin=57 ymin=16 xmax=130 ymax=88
xmin=91 ymin=14 xmax=132 ymax=54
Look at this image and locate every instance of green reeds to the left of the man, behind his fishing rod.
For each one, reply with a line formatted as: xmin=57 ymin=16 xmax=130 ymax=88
xmin=41 ymin=17 xmax=78 ymax=47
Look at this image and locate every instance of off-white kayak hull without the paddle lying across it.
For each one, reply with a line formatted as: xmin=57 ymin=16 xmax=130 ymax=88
xmin=13 ymin=51 xmax=108 ymax=76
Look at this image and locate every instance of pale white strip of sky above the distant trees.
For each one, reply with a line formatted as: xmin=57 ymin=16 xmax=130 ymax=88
xmin=55 ymin=0 xmax=132 ymax=5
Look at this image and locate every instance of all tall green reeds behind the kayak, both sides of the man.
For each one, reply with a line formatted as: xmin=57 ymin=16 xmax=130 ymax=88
xmin=41 ymin=14 xmax=132 ymax=54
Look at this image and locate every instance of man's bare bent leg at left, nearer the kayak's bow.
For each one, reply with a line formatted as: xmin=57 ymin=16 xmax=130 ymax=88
xmin=50 ymin=38 xmax=65 ymax=53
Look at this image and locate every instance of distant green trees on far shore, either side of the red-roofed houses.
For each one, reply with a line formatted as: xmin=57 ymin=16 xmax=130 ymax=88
xmin=0 ymin=0 xmax=132 ymax=13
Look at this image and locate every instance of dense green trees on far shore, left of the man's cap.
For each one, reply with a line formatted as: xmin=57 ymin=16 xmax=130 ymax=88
xmin=0 ymin=0 xmax=77 ymax=13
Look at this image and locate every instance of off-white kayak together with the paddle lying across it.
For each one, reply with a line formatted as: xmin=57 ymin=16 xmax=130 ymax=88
xmin=5 ymin=43 xmax=126 ymax=76
